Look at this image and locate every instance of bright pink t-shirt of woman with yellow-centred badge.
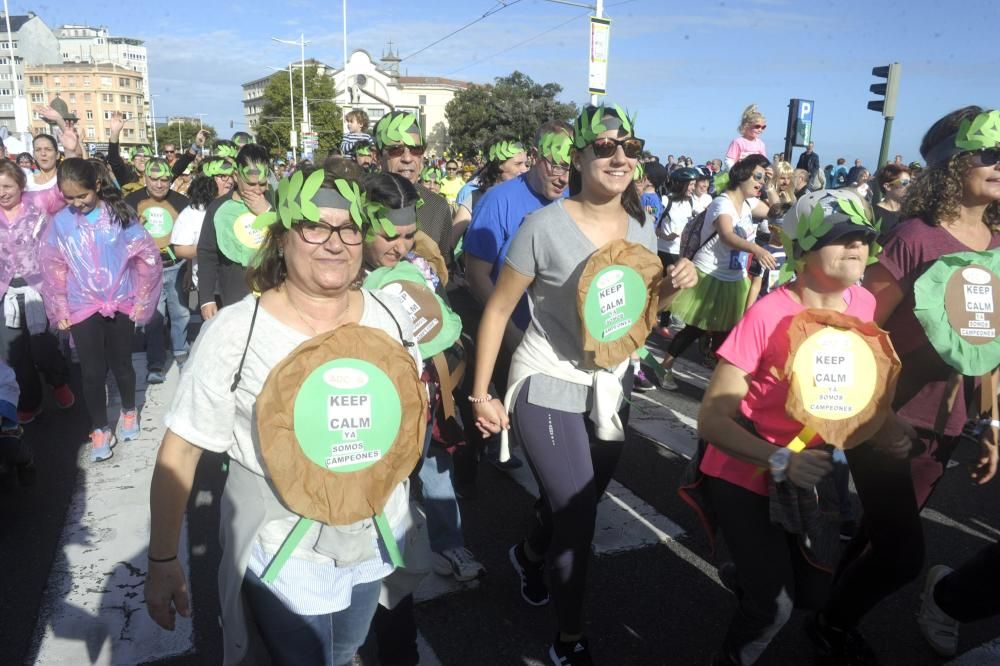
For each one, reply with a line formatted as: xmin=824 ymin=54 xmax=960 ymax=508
xmin=701 ymin=285 xmax=875 ymax=495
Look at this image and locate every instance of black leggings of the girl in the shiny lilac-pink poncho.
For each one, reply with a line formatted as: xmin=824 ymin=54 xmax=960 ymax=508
xmin=71 ymin=312 xmax=135 ymax=430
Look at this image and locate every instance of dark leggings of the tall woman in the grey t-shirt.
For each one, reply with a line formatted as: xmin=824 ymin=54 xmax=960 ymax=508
xmin=511 ymin=378 xmax=631 ymax=634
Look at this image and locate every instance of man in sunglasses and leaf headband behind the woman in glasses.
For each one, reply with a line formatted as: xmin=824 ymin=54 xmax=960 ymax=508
xmin=375 ymin=111 xmax=453 ymax=268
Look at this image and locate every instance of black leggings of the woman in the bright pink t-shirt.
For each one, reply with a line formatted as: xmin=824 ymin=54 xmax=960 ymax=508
xmin=703 ymin=476 xmax=832 ymax=665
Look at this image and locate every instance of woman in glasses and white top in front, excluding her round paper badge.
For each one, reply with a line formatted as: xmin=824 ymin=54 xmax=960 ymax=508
xmin=145 ymin=166 xmax=421 ymax=666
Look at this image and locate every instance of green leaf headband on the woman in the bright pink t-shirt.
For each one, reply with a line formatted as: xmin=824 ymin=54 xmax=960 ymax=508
xmin=778 ymin=194 xmax=882 ymax=284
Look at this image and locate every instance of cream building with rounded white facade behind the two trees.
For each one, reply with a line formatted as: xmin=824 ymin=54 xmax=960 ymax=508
xmin=243 ymin=49 xmax=469 ymax=154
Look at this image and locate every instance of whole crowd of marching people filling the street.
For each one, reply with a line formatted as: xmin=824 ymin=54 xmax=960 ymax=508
xmin=0 ymin=100 xmax=1000 ymax=666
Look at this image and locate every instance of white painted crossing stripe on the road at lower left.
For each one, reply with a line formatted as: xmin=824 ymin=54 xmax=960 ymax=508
xmin=29 ymin=353 xmax=193 ymax=665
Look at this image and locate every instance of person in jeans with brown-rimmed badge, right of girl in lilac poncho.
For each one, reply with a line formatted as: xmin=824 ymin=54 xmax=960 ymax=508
xmin=125 ymin=157 xmax=191 ymax=384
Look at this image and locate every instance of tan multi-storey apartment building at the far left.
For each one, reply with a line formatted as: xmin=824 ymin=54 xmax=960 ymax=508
xmin=24 ymin=63 xmax=151 ymax=150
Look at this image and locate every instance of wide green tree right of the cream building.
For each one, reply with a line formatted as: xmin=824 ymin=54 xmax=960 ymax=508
xmin=445 ymin=71 xmax=577 ymax=155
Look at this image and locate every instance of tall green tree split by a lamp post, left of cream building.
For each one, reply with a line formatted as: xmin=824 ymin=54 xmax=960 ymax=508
xmin=250 ymin=65 xmax=344 ymax=157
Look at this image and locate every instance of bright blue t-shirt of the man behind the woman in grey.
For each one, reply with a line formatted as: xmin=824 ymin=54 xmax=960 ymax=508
xmin=463 ymin=174 xmax=551 ymax=331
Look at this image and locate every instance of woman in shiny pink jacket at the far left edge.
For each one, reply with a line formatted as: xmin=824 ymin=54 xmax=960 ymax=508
xmin=0 ymin=160 xmax=76 ymax=424
